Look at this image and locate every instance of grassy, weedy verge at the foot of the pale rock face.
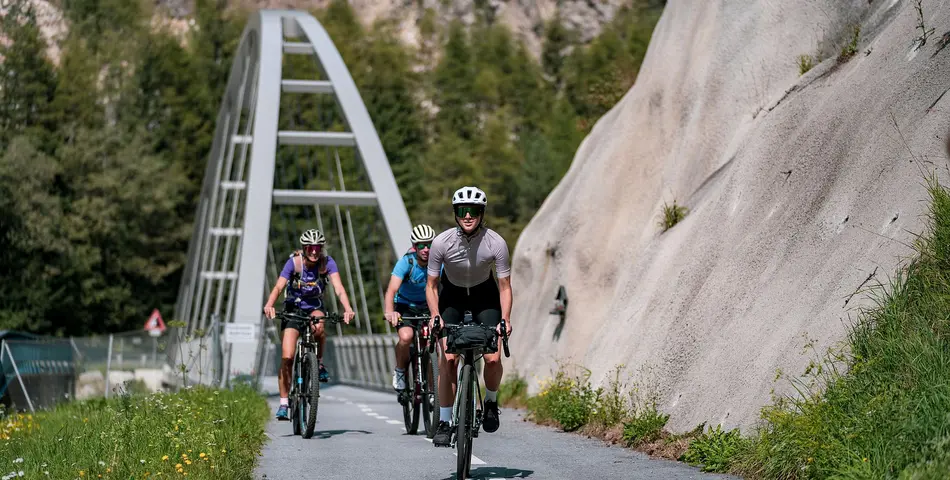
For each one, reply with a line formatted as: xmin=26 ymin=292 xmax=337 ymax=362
xmin=506 ymin=178 xmax=950 ymax=479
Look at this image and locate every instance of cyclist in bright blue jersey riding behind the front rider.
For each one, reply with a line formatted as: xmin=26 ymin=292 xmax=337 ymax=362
xmin=383 ymin=225 xmax=435 ymax=391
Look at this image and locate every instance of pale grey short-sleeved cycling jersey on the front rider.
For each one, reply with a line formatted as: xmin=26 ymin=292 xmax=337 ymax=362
xmin=428 ymin=227 xmax=511 ymax=288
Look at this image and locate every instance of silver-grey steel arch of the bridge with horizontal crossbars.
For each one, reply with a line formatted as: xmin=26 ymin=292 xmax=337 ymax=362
xmin=170 ymin=10 xmax=411 ymax=382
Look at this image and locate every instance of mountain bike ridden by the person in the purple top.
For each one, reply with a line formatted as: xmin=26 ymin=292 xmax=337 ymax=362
xmin=277 ymin=310 xmax=343 ymax=438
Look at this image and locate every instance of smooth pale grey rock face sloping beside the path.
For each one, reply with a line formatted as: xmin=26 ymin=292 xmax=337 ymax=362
xmin=510 ymin=0 xmax=950 ymax=431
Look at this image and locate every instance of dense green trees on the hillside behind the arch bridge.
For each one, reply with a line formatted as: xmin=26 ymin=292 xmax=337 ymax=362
xmin=0 ymin=0 xmax=662 ymax=335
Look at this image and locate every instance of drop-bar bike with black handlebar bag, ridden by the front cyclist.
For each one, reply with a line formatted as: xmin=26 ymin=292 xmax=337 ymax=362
xmin=430 ymin=312 xmax=511 ymax=480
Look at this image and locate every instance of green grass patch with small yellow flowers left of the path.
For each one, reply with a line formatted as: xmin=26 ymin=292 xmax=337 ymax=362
xmin=0 ymin=387 xmax=269 ymax=480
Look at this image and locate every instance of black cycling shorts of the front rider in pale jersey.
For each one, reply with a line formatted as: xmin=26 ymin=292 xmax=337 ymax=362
xmin=439 ymin=274 xmax=501 ymax=327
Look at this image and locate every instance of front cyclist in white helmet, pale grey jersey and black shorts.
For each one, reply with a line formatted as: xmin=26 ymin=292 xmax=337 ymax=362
xmin=426 ymin=187 xmax=512 ymax=447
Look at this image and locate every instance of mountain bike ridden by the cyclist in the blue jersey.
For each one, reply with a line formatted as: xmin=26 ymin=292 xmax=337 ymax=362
xmin=390 ymin=314 xmax=439 ymax=438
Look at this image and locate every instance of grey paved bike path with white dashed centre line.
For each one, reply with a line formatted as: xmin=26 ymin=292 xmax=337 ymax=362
xmin=255 ymin=385 xmax=735 ymax=480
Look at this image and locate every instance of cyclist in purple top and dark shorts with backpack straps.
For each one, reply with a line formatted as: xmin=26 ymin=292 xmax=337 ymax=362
xmin=264 ymin=229 xmax=356 ymax=420
